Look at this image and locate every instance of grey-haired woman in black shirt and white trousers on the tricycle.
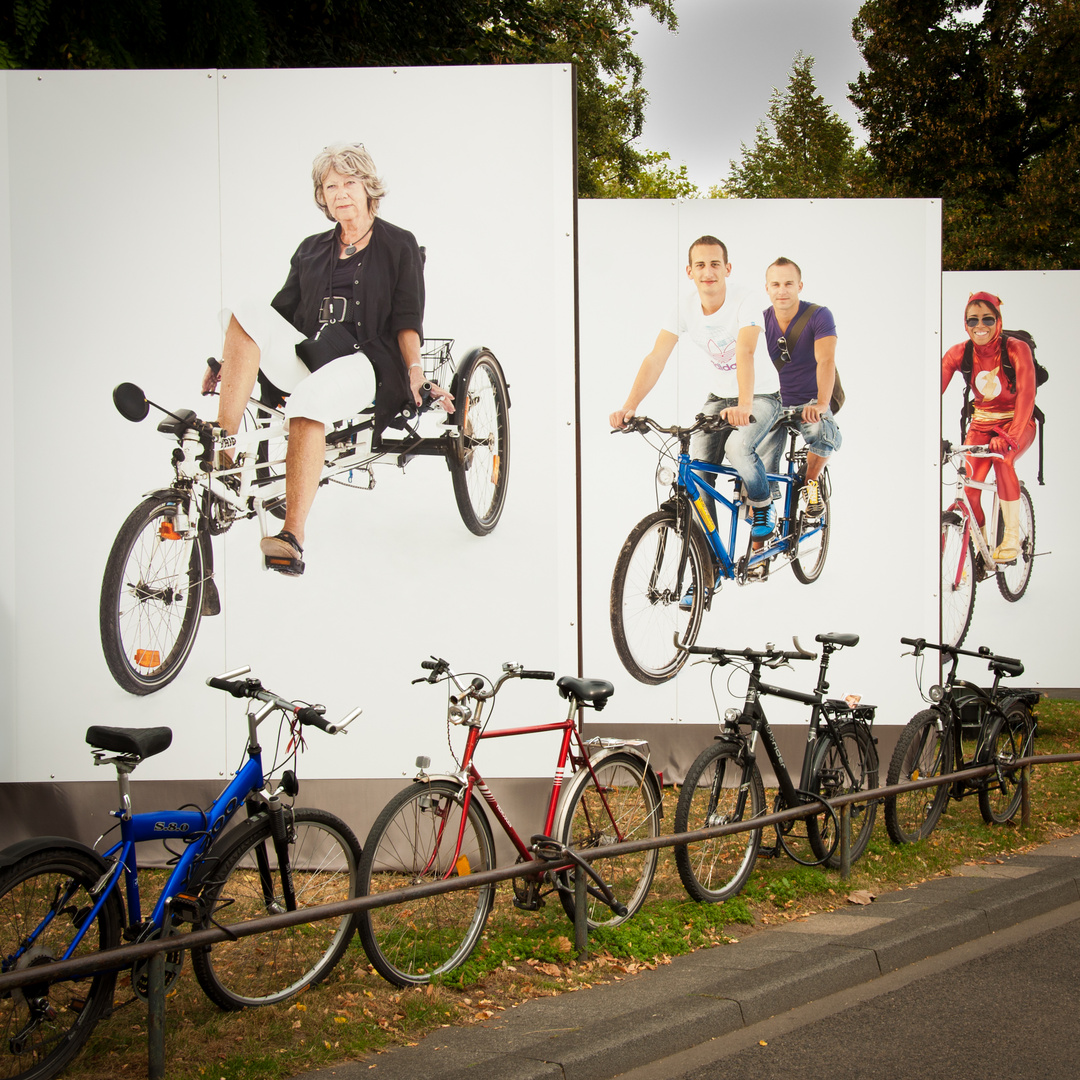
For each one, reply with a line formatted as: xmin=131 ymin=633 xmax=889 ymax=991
xmin=203 ymin=143 xmax=453 ymax=575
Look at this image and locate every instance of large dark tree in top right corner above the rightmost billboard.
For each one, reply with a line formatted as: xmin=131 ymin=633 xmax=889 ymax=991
xmin=851 ymin=0 xmax=1080 ymax=270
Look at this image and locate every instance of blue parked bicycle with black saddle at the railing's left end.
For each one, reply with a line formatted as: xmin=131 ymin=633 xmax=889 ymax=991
xmin=0 ymin=667 xmax=361 ymax=1080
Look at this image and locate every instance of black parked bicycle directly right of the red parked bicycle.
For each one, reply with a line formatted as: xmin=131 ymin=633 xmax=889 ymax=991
xmin=675 ymin=634 xmax=878 ymax=903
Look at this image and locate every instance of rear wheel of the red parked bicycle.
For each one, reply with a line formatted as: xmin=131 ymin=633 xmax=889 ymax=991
xmin=557 ymin=752 xmax=661 ymax=930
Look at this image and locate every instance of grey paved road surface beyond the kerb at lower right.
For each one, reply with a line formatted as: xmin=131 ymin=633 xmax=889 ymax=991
xmin=620 ymin=904 xmax=1080 ymax=1080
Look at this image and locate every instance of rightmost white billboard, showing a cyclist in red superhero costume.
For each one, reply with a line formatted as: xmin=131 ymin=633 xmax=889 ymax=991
xmin=940 ymin=270 xmax=1067 ymax=688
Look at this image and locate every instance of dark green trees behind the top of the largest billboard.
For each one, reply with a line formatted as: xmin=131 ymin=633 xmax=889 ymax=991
xmin=0 ymin=0 xmax=676 ymax=195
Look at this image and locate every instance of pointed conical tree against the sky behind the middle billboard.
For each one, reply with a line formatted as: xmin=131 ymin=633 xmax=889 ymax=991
xmin=711 ymin=53 xmax=867 ymax=199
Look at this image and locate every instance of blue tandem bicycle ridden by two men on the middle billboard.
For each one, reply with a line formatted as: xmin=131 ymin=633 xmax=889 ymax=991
xmin=611 ymin=409 xmax=832 ymax=685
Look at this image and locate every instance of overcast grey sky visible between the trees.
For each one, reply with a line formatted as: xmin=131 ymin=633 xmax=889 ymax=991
xmin=634 ymin=0 xmax=863 ymax=187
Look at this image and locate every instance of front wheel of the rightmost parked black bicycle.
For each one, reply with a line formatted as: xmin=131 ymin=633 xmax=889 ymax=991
xmin=885 ymin=708 xmax=953 ymax=843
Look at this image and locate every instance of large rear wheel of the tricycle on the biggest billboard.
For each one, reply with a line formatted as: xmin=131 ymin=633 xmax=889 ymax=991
xmin=446 ymin=349 xmax=510 ymax=537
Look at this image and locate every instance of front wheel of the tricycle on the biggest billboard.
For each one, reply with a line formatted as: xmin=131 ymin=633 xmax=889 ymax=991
xmin=98 ymin=492 xmax=204 ymax=696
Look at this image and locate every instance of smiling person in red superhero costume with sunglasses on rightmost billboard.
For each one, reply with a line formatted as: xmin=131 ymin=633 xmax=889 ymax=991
xmin=942 ymin=293 xmax=1036 ymax=563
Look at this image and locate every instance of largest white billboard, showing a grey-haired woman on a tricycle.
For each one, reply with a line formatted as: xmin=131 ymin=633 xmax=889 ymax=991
xmin=0 ymin=65 xmax=577 ymax=840
